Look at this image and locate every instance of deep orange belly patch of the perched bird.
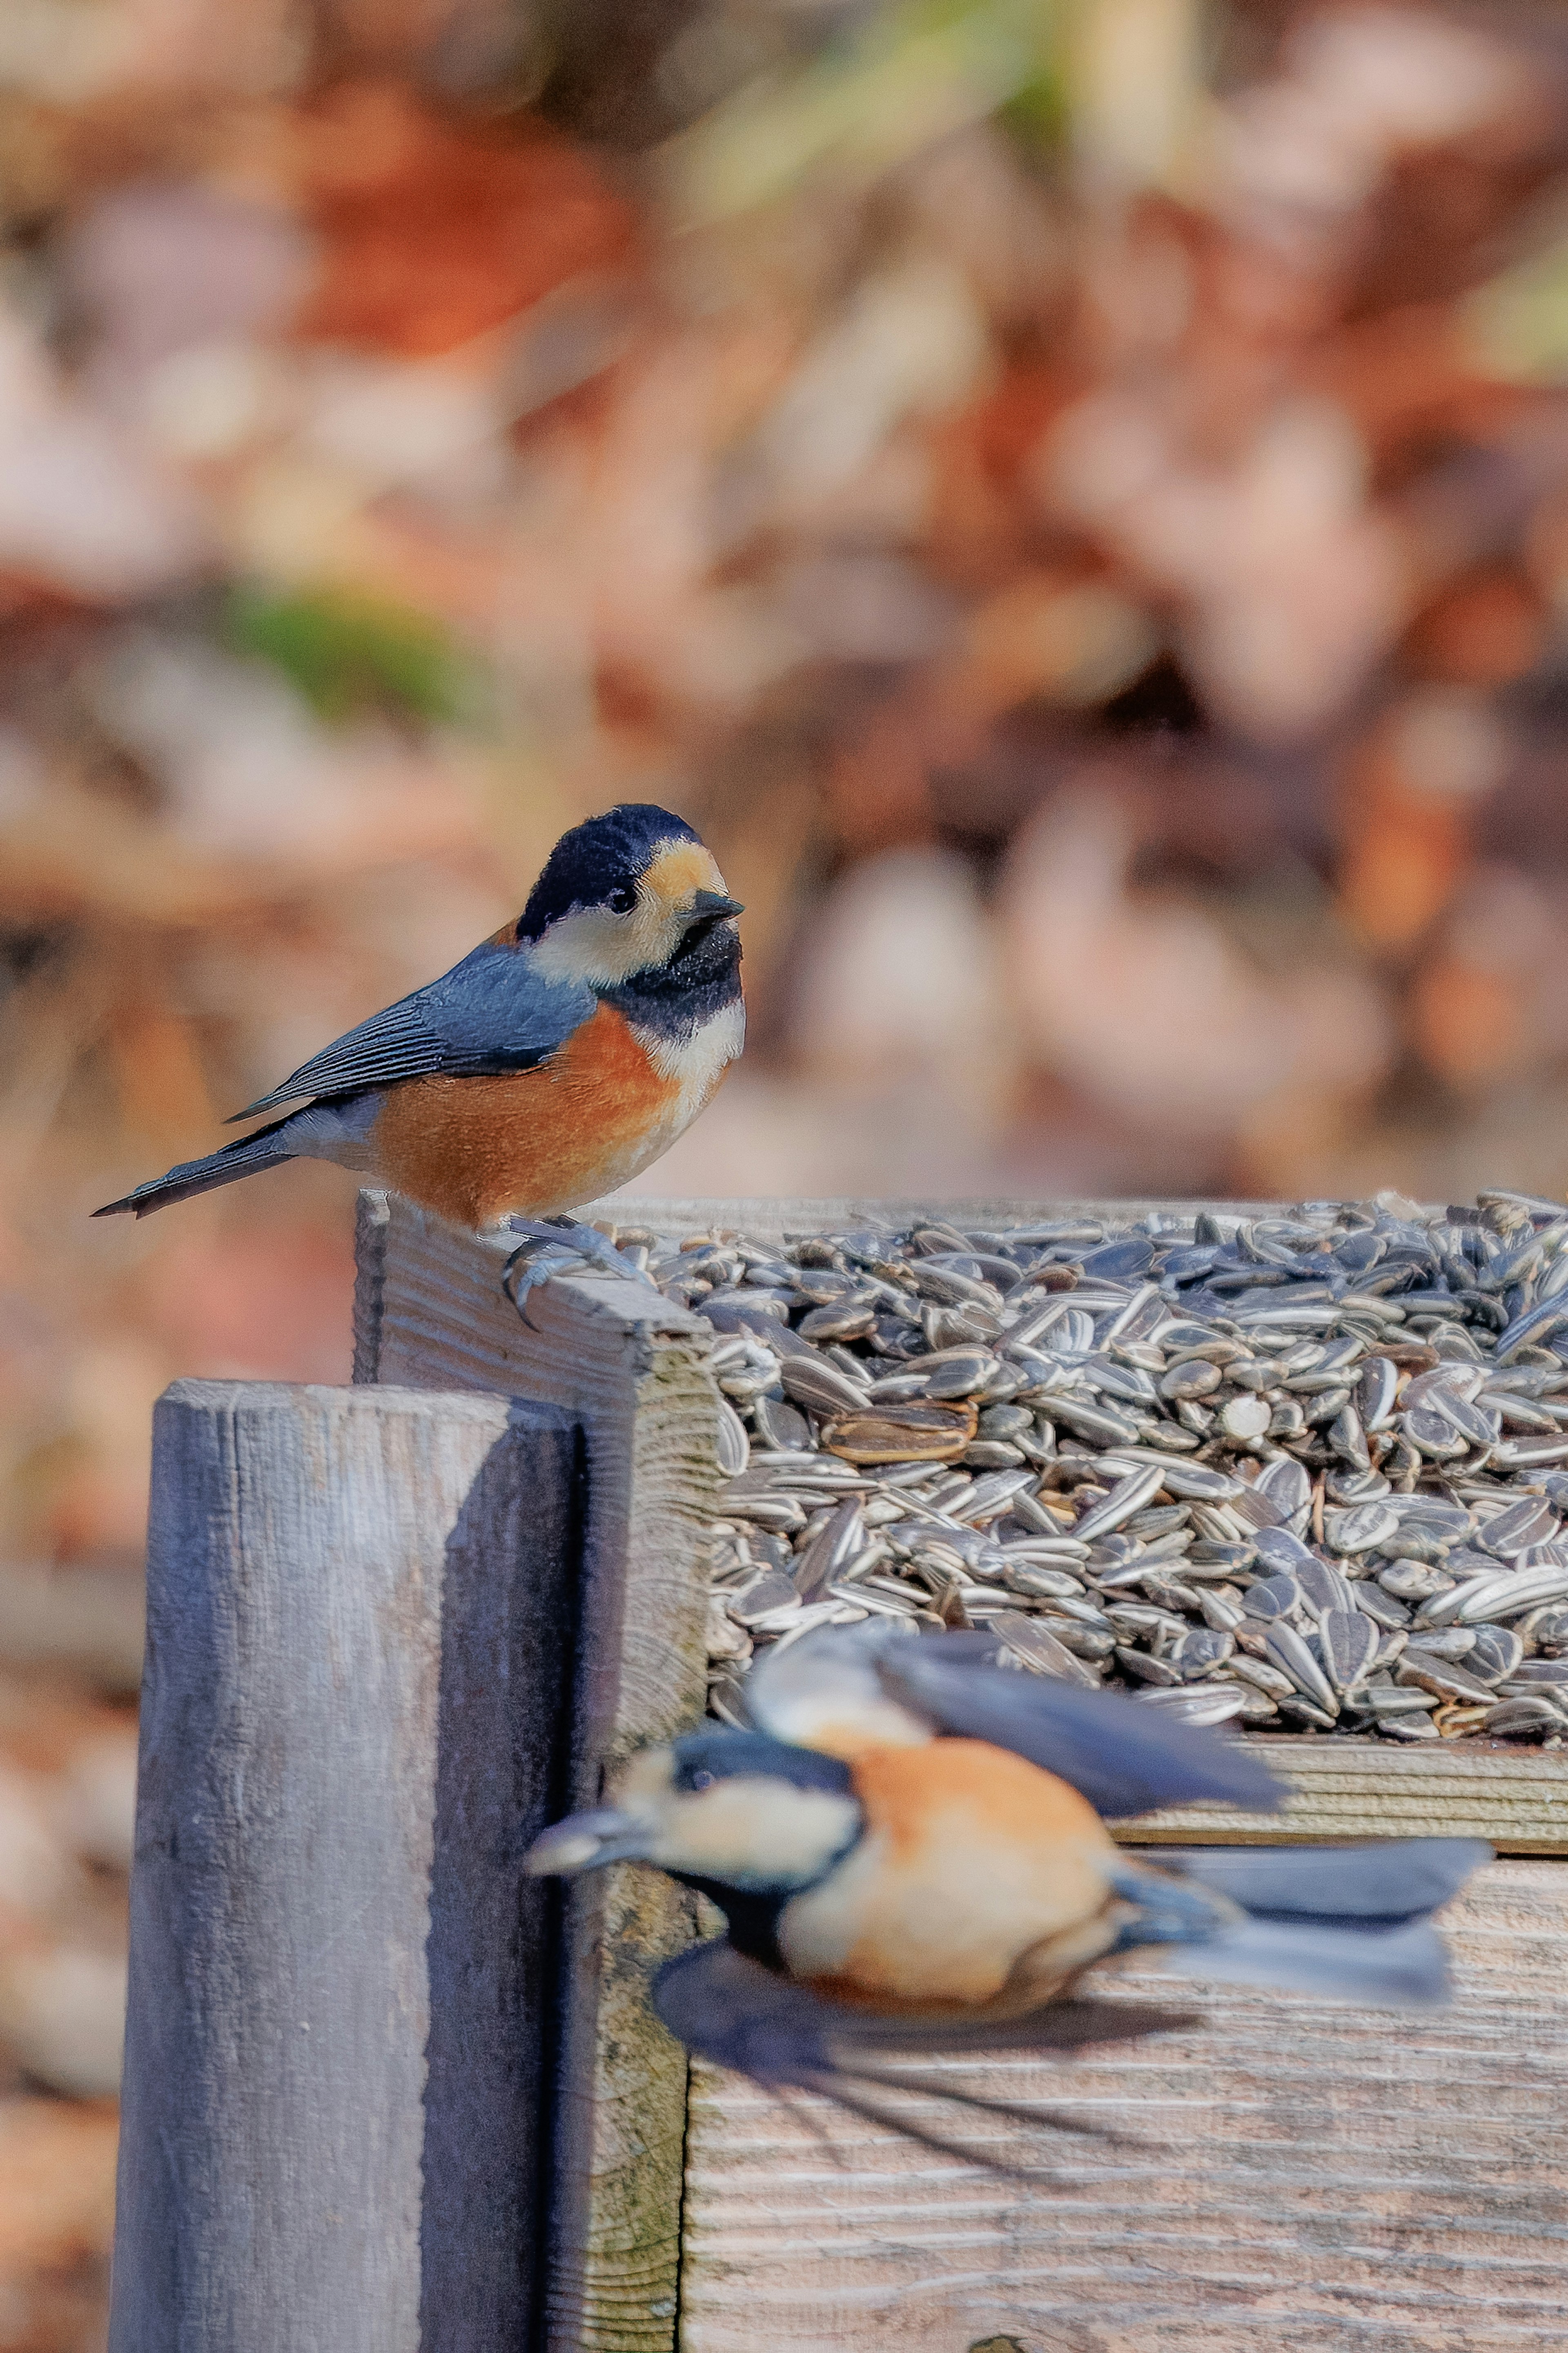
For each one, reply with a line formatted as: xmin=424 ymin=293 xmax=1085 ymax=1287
xmin=372 ymin=1005 xmax=679 ymax=1228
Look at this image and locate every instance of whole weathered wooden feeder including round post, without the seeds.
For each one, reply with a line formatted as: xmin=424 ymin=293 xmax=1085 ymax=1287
xmin=111 ymin=1195 xmax=1568 ymax=2353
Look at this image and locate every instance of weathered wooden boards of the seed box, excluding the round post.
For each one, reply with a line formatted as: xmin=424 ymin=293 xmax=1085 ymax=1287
xmin=355 ymin=1195 xmax=1568 ymax=2353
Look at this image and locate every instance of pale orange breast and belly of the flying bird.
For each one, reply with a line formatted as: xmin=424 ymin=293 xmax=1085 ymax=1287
xmin=780 ymin=1739 xmax=1114 ymax=2007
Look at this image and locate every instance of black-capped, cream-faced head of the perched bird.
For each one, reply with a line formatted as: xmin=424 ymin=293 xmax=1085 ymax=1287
xmin=517 ymin=803 xmax=743 ymax=995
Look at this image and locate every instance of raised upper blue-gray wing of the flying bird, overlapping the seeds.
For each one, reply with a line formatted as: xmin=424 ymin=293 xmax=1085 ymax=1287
xmin=879 ymin=1633 xmax=1283 ymax=1821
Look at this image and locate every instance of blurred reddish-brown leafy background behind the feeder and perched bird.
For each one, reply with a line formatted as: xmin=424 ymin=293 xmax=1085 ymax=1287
xmin=0 ymin=0 xmax=1568 ymax=2353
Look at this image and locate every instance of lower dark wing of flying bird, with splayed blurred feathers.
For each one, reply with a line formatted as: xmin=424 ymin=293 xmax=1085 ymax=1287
xmin=653 ymin=1936 xmax=1199 ymax=2179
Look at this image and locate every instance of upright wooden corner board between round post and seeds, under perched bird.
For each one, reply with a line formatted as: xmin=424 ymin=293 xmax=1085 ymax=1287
xmin=355 ymin=1195 xmax=719 ymax=2353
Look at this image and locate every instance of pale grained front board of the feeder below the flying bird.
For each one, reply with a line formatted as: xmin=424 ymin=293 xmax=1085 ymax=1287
xmin=682 ymin=1861 xmax=1568 ymax=2353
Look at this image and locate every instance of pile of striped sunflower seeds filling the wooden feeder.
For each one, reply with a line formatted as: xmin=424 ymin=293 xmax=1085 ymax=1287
xmin=614 ymin=1193 xmax=1568 ymax=1746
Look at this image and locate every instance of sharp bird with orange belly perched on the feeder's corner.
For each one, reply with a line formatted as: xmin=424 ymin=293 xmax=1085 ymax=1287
xmin=94 ymin=803 xmax=745 ymax=1299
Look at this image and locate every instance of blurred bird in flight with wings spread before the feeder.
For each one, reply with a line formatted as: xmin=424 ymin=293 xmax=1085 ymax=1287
xmin=529 ymin=1621 xmax=1490 ymax=2146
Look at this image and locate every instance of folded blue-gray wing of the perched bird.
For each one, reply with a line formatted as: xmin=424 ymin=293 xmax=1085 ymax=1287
xmin=235 ymin=941 xmax=597 ymax=1120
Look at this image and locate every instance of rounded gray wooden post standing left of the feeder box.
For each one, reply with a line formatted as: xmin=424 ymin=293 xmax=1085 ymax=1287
xmin=111 ymin=1381 xmax=583 ymax=2353
